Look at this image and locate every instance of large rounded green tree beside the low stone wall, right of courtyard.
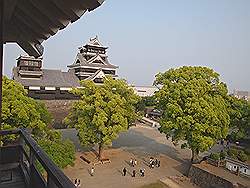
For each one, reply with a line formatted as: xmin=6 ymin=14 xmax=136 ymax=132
xmin=155 ymin=66 xmax=230 ymax=162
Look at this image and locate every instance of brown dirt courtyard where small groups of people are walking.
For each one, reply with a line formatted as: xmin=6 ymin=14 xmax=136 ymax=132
xmin=64 ymin=126 xmax=197 ymax=188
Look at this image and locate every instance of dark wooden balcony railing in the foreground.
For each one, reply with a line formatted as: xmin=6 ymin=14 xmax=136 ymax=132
xmin=0 ymin=129 xmax=75 ymax=188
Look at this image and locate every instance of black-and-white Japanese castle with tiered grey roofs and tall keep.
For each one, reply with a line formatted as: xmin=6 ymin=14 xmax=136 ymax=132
xmin=13 ymin=37 xmax=118 ymax=99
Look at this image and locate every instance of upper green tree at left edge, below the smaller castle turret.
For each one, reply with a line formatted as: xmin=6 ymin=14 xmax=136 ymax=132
xmin=1 ymin=77 xmax=49 ymax=142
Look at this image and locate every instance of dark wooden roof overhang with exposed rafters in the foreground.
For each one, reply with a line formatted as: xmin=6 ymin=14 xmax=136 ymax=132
xmin=0 ymin=0 xmax=104 ymax=57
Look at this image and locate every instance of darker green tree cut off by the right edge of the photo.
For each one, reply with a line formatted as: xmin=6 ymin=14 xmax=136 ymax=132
xmin=228 ymin=96 xmax=250 ymax=141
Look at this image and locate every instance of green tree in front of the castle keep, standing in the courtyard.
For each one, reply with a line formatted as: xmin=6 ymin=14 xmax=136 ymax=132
xmin=65 ymin=77 xmax=138 ymax=159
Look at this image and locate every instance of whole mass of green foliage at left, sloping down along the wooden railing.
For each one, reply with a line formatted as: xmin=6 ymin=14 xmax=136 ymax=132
xmin=0 ymin=77 xmax=75 ymax=168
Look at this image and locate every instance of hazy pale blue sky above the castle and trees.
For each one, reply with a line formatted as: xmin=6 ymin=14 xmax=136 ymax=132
xmin=4 ymin=0 xmax=250 ymax=90
